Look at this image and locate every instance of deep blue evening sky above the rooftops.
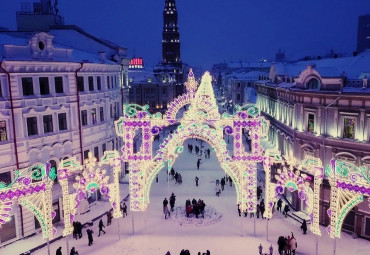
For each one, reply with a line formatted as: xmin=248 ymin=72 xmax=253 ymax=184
xmin=0 ymin=0 xmax=370 ymax=68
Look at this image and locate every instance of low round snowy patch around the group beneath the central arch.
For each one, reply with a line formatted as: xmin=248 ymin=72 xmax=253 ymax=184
xmin=171 ymin=205 xmax=222 ymax=227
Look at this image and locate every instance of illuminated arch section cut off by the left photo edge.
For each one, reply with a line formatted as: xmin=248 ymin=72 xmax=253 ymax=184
xmin=0 ymin=163 xmax=56 ymax=239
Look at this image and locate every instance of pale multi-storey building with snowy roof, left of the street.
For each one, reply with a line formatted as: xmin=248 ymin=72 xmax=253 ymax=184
xmin=0 ymin=1 xmax=128 ymax=246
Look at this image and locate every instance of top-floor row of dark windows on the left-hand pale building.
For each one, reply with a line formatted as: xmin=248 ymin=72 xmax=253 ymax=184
xmin=20 ymin=75 xmax=118 ymax=96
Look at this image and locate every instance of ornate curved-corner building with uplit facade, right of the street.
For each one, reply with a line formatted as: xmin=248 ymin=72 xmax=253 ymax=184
xmin=256 ymin=51 xmax=370 ymax=239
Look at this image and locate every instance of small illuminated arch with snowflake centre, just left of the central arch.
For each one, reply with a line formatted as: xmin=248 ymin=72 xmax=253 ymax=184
xmin=58 ymin=151 xmax=122 ymax=236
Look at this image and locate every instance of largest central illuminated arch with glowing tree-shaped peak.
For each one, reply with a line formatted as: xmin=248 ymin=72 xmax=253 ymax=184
xmin=115 ymin=70 xmax=269 ymax=212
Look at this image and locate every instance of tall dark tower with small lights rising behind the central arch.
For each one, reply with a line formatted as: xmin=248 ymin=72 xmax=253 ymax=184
xmin=154 ymin=0 xmax=184 ymax=95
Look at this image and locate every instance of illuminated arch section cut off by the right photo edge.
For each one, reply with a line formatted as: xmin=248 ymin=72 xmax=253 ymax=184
xmin=325 ymin=159 xmax=370 ymax=238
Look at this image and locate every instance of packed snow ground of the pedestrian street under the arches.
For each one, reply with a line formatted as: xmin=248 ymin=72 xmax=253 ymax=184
xmin=0 ymin=137 xmax=370 ymax=255
